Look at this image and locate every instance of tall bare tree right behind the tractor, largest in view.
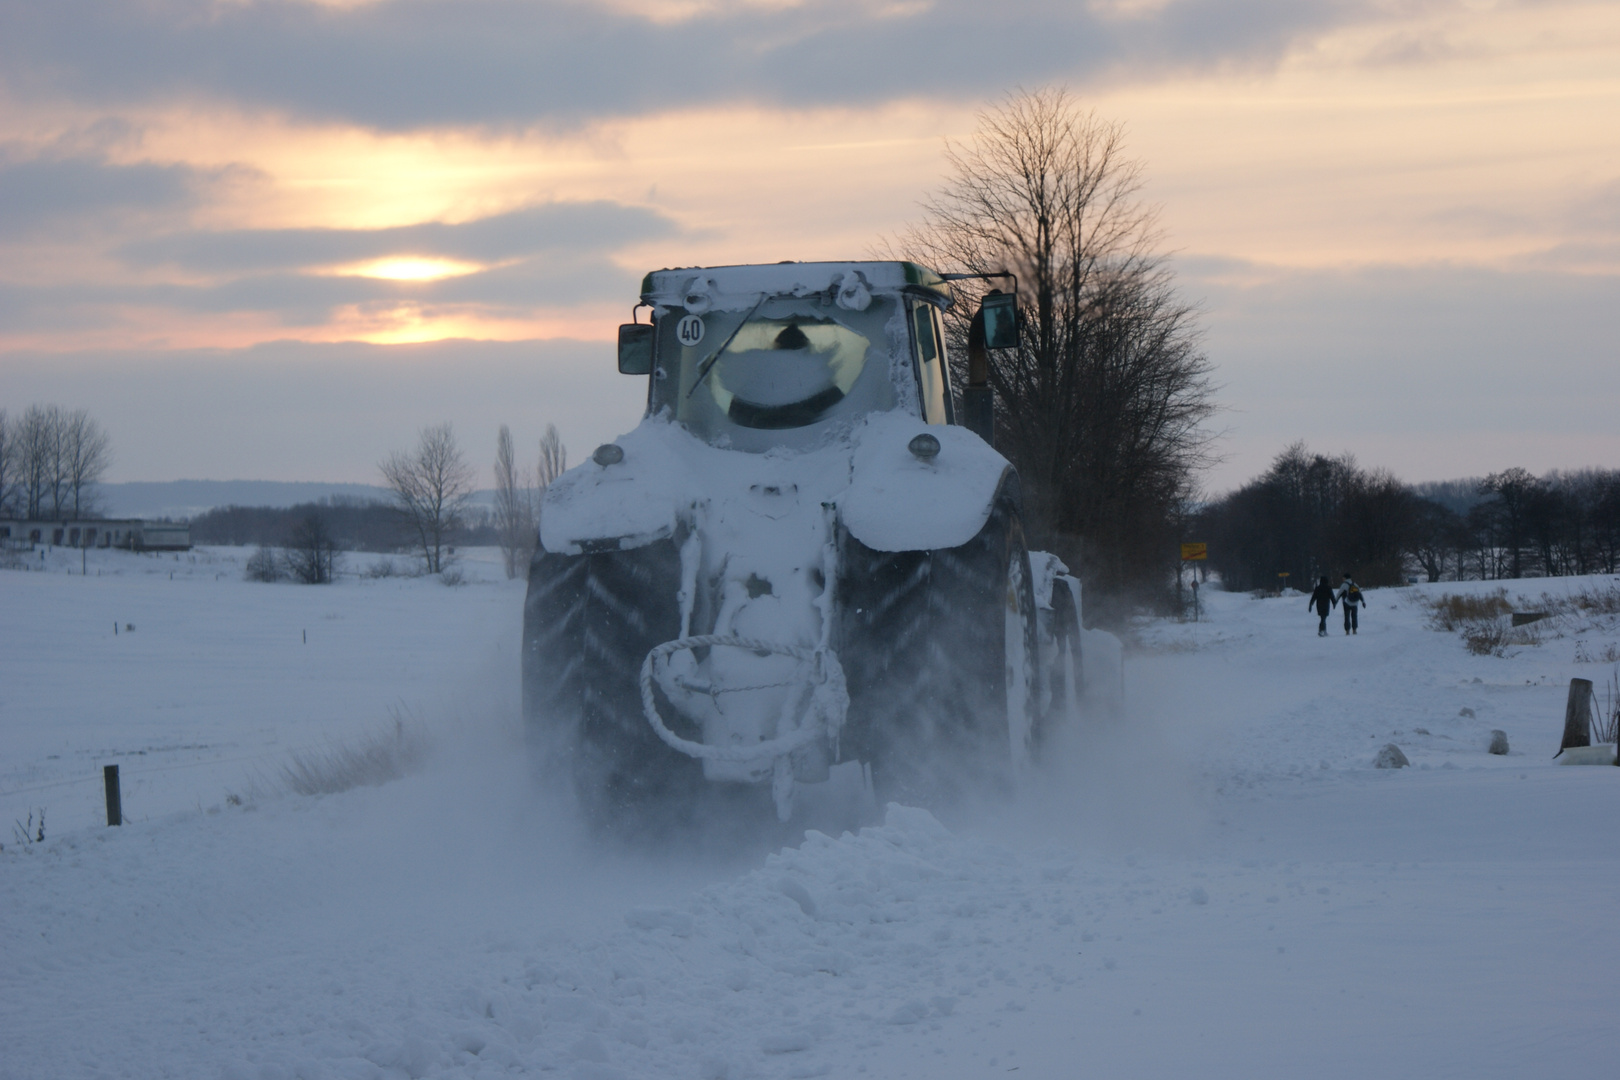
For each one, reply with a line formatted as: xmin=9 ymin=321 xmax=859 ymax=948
xmin=901 ymin=89 xmax=1213 ymax=615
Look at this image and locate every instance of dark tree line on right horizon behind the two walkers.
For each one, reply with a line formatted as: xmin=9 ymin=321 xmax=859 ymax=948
xmin=1187 ymin=442 xmax=1620 ymax=591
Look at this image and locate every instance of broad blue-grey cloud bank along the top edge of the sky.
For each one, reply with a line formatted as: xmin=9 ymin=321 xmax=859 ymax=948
xmin=0 ymin=0 xmax=1382 ymax=138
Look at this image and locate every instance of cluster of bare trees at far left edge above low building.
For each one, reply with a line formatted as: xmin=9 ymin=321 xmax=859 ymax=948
xmin=0 ymin=405 xmax=112 ymax=521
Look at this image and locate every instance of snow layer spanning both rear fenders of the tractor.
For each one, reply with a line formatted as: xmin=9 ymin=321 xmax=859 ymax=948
xmin=539 ymin=413 xmax=1011 ymax=555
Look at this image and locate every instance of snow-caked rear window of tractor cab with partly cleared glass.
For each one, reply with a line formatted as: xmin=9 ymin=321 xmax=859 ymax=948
xmin=658 ymin=295 xmax=904 ymax=450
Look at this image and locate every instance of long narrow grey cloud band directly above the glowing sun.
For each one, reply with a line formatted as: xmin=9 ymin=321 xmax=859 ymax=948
xmin=120 ymin=201 xmax=677 ymax=274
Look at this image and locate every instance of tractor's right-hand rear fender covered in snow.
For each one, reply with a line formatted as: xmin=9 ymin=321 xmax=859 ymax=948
xmin=839 ymin=413 xmax=1016 ymax=551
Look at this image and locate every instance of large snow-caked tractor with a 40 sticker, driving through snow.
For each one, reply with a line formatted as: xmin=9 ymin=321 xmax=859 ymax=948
xmin=523 ymin=262 xmax=1121 ymax=823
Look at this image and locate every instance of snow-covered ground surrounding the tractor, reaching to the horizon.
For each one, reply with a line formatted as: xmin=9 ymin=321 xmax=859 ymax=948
xmin=0 ymin=549 xmax=1620 ymax=1080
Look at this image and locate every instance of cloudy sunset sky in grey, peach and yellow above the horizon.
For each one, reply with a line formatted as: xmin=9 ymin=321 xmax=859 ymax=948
xmin=0 ymin=0 xmax=1620 ymax=494
